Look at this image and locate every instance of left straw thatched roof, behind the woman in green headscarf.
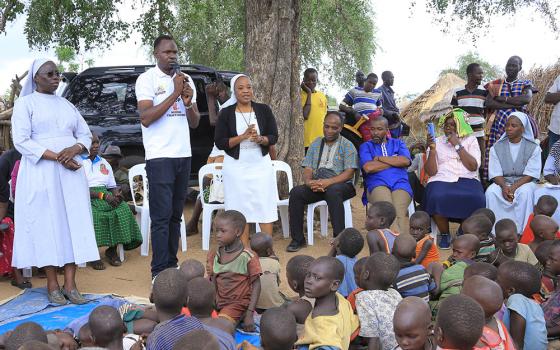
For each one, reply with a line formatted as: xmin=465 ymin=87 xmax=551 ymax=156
xmin=401 ymin=73 xmax=466 ymax=138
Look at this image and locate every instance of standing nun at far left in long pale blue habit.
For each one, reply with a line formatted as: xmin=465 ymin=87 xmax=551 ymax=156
xmin=12 ymin=59 xmax=99 ymax=305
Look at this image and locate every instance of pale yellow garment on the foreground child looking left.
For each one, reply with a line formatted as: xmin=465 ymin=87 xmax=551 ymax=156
xmin=296 ymin=293 xmax=360 ymax=350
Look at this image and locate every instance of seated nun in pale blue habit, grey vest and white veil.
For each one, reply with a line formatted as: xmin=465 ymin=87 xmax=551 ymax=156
xmin=486 ymin=112 xmax=541 ymax=232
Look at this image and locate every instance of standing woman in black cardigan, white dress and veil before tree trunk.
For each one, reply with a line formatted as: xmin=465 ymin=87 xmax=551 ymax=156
xmin=214 ymin=74 xmax=278 ymax=247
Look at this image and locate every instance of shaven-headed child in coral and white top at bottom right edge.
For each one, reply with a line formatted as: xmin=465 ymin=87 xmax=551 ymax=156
xmin=461 ymin=276 xmax=515 ymax=350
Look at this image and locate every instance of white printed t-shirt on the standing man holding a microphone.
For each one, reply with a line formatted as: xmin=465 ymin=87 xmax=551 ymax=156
xmin=136 ymin=66 xmax=196 ymax=160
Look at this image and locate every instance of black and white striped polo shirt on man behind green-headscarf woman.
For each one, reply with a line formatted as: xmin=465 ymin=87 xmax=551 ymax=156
xmin=451 ymin=85 xmax=488 ymax=137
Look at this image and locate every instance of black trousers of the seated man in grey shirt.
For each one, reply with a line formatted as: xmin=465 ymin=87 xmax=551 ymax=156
xmin=289 ymin=183 xmax=356 ymax=244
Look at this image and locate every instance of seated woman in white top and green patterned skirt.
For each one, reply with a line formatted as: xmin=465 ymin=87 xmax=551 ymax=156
xmin=83 ymin=134 xmax=142 ymax=270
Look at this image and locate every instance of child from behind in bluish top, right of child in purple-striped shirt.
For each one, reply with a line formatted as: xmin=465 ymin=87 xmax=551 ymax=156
xmin=187 ymin=277 xmax=235 ymax=350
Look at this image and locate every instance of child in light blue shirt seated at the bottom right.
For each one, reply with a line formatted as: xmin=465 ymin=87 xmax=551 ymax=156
xmin=498 ymin=260 xmax=547 ymax=350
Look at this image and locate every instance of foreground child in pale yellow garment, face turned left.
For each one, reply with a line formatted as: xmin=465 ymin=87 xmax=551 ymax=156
xmin=296 ymin=256 xmax=361 ymax=349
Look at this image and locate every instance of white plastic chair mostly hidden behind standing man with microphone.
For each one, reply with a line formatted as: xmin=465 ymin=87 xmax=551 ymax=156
xmin=128 ymin=164 xmax=187 ymax=256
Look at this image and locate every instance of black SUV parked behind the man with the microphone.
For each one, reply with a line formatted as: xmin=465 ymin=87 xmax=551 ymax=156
xmin=62 ymin=65 xmax=237 ymax=181
